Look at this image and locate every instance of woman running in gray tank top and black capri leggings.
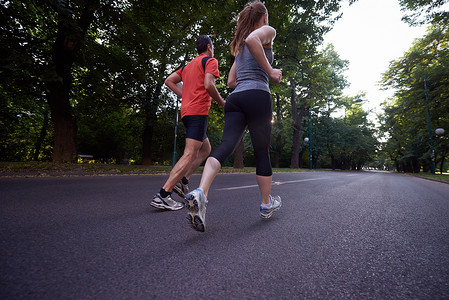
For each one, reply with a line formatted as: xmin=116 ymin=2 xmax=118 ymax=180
xmin=185 ymin=1 xmax=282 ymax=231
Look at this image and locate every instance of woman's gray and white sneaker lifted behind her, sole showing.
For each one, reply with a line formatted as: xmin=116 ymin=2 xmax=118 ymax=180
xmin=184 ymin=188 xmax=208 ymax=232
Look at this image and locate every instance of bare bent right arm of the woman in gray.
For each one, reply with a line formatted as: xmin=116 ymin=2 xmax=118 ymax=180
xmin=245 ymin=25 xmax=282 ymax=83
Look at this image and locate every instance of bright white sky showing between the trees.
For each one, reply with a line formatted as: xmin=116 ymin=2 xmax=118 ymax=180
xmin=324 ymin=0 xmax=427 ymax=121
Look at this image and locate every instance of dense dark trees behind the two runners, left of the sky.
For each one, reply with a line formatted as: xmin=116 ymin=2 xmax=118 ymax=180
xmin=0 ymin=0 xmax=402 ymax=169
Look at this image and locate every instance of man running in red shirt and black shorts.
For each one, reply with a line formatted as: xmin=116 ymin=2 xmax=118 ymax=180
xmin=151 ymin=35 xmax=225 ymax=210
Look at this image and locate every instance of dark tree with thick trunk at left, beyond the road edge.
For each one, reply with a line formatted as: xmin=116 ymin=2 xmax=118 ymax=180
xmin=2 ymin=0 xmax=130 ymax=162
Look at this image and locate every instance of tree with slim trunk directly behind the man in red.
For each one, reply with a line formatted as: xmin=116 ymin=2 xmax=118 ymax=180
xmin=117 ymin=1 xmax=242 ymax=164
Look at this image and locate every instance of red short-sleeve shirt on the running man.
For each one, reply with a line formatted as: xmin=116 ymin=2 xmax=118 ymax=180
xmin=176 ymin=53 xmax=220 ymax=118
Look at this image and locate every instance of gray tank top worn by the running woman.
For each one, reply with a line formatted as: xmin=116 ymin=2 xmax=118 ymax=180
xmin=232 ymin=44 xmax=273 ymax=93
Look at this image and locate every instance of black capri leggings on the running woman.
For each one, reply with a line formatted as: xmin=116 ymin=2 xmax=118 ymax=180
xmin=211 ymin=90 xmax=273 ymax=176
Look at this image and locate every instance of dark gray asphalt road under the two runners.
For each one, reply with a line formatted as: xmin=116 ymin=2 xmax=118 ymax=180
xmin=0 ymin=172 xmax=449 ymax=299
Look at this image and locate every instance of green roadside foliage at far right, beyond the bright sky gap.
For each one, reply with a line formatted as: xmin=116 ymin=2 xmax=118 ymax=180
xmin=377 ymin=0 xmax=449 ymax=173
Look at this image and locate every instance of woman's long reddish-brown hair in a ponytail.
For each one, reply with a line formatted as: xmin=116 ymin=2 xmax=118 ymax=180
xmin=231 ymin=1 xmax=267 ymax=56
